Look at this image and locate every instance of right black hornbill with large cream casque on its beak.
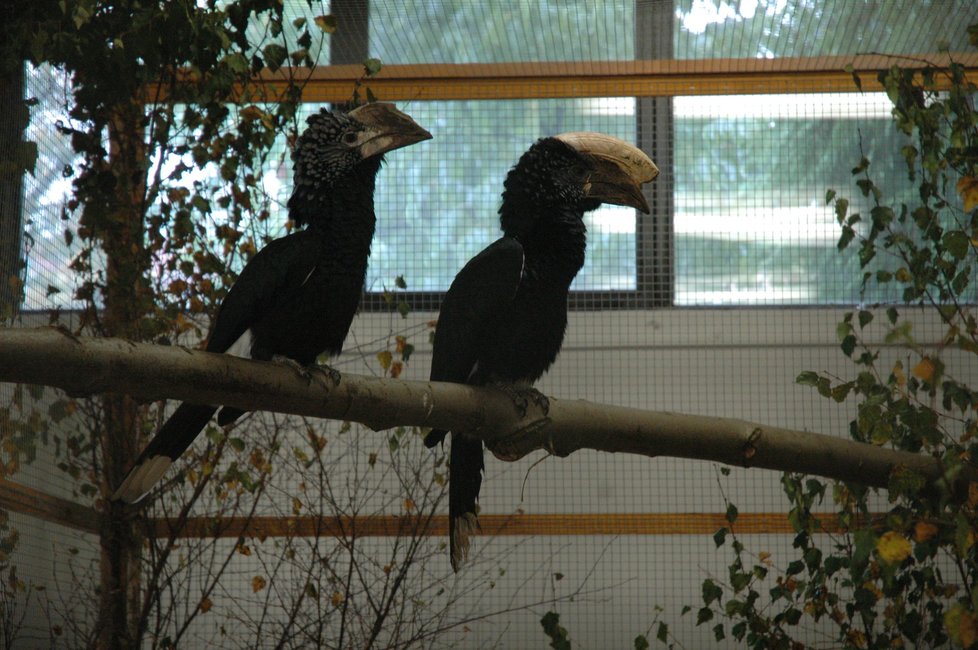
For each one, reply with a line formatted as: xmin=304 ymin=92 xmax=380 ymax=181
xmin=425 ymin=133 xmax=658 ymax=571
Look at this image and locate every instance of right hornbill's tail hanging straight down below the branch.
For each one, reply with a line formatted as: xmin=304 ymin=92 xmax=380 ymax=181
xmin=448 ymin=433 xmax=484 ymax=572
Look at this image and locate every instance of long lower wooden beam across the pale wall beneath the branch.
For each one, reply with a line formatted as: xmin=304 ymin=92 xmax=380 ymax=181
xmin=150 ymin=512 xmax=876 ymax=539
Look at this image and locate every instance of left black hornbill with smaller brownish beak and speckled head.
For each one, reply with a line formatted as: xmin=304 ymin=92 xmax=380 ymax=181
xmin=112 ymin=103 xmax=431 ymax=503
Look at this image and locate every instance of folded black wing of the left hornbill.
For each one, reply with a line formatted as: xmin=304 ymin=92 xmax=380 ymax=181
xmin=207 ymin=230 xmax=316 ymax=356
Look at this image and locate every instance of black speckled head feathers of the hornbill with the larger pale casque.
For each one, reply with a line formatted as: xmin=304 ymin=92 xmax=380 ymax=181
xmin=499 ymin=138 xmax=601 ymax=238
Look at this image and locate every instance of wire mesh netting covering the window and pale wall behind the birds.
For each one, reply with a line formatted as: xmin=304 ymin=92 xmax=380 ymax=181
xmin=0 ymin=0 xmax=976 ymax=648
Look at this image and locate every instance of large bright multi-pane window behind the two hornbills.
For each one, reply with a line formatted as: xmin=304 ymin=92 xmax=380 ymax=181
xmin=13 ymin=0 xmax=969 ymax=309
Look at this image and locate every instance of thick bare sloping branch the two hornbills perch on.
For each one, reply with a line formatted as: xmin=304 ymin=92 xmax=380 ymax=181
xmin=0 ymin=328 xmax=943 ymax=488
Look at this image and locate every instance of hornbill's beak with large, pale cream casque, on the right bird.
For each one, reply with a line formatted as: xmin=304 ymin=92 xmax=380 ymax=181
xmin=556 ymin=131 xmax=659 ymax=214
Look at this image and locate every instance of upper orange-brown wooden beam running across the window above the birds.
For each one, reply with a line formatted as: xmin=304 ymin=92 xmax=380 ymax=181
xmin=212 ymin=53 xmax=978 ymax=102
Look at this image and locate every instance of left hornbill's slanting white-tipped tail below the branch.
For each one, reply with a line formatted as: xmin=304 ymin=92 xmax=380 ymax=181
xmin=112 ymin=402 xmax=217 ymax=503
